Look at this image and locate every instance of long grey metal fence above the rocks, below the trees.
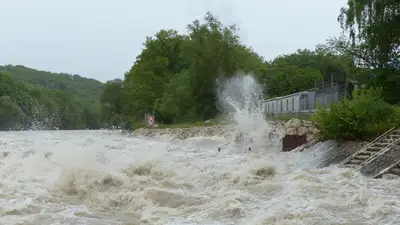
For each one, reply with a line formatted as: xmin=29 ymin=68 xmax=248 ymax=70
xmin=263 ymin=83 xmax=348 ymax=115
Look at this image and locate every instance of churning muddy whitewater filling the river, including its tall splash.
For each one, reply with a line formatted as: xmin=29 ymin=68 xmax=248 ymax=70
xmin=0 ymin=76 xmax=400 ymax=225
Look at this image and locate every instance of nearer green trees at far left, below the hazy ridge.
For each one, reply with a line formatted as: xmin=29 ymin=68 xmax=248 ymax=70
xmin=0 ymin=73 xmax=101 ymax=130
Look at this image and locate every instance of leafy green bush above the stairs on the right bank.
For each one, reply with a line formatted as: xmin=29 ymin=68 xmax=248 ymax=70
xmin=313 ymin=89 xmax=400 ymax=140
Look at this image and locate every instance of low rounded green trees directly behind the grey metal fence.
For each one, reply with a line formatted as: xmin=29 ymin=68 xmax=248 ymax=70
xmin=261 ymin=49 xmax=352 ymax=97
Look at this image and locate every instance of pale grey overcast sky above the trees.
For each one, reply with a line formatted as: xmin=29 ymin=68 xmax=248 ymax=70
xmin=0 ymin=0 xmax=347 ymax=81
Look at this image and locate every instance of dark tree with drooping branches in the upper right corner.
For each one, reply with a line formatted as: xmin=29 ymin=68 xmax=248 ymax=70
xmin=338 ymin=0 xmax=400 ymax=103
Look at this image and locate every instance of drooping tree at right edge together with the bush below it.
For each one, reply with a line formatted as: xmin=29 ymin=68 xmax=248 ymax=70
xmin=315 ymin=0 xmax=400 ymax=139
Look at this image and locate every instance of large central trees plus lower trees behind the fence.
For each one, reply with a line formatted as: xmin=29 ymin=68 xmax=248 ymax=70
xmin=101 ymin=13 xmax=353 ymax=128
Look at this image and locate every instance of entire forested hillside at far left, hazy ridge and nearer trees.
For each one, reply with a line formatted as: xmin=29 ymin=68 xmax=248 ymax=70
xmin=0 ymin=65 xmax=104 ymax=130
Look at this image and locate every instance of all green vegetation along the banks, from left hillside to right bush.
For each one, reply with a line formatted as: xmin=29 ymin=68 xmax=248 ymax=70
xmin=0 ymin=0 xmax=400 ymax=139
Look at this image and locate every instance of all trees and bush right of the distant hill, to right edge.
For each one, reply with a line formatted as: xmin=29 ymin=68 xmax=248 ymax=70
xmin=101 ymin=0 xmax=400 ymax=139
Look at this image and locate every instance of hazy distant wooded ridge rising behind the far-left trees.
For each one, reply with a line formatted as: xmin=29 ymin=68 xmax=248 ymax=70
xmin=0 ymin=65 xmax=104 ymax=102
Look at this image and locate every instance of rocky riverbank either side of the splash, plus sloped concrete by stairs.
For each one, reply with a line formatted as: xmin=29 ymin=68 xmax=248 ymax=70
xmin=133 ymin=118 xmax=367 ymax=167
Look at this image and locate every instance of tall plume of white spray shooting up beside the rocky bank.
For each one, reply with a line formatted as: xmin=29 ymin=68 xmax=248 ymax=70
xmin=217 ymin=74 xmax=272 ymax=149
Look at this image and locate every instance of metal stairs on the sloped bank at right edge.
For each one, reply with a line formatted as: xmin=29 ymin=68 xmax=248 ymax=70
xmin=340 ymin=127 xmax=400 ymax=178
